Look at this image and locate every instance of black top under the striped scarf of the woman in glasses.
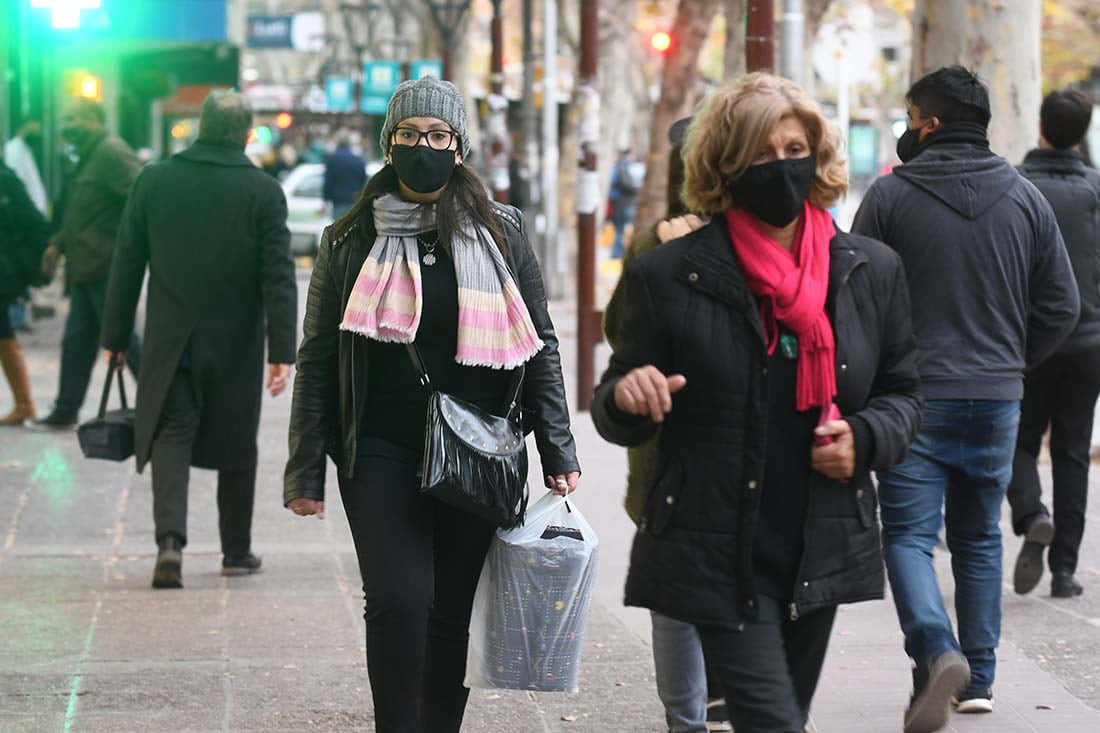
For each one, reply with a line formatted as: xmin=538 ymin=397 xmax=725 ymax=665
xmin=363 ymin=231 xmax=513 ymax=453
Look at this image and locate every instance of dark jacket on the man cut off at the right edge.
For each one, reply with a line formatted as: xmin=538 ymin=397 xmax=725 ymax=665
xmin=1020 ymin=149 xmax=1100 ymax=353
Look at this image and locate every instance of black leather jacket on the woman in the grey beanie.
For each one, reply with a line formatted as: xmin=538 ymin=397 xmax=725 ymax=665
xmin=283 ymin=204 xmax=580 ymax=504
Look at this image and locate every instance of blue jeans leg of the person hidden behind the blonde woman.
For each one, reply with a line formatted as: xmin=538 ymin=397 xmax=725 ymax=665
xmin=650 ymin=611 xmax=707 ymax=733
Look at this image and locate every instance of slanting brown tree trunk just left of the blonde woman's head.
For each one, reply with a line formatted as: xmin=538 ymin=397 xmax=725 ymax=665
xmin=634 ymin=0 xmax=718 ymax=231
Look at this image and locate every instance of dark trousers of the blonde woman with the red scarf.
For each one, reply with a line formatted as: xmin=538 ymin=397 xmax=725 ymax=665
xmin=699 ymin=595 xmax=836 ymax=733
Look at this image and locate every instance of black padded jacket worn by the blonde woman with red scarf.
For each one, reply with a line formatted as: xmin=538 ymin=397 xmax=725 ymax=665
xmin=592 ymin=217 xmax=922 ymax=625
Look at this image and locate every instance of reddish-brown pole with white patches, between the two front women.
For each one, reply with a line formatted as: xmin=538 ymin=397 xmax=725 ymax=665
xmin=576 ymin=0 xmax=601 ymax=411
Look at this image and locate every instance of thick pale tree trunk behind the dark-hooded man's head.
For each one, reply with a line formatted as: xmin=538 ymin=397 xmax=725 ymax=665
xmin=913 ymin=0 xmax=1042 ymax=163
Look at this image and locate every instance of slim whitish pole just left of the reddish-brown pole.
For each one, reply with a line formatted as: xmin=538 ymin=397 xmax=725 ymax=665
xmin=542 ymin=0 xmax=561 ymax=297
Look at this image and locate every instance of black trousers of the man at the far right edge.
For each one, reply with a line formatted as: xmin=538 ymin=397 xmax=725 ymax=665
xmin=1009 ymin=349 xmax=1100 ymax=573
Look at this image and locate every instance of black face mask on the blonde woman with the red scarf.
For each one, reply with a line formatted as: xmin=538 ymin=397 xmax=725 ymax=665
xmin=729 ymin=155 xmax=817 ymax=228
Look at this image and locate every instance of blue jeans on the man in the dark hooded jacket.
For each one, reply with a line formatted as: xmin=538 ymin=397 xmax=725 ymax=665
xmin=879 ymin=400 xmax=1020 ymax=691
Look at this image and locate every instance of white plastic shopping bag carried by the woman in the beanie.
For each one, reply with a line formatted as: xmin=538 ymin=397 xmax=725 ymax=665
xmin=465 ymin=492 xmax=600 ymax=692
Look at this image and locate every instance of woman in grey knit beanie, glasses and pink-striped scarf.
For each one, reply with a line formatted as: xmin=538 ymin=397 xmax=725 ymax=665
xmin=284 ymin=77 xmax=580 ymax=733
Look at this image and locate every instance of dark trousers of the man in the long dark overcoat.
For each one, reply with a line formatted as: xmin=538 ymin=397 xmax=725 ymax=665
xmin=151 ymin=370 xmax=256 ymax=557
